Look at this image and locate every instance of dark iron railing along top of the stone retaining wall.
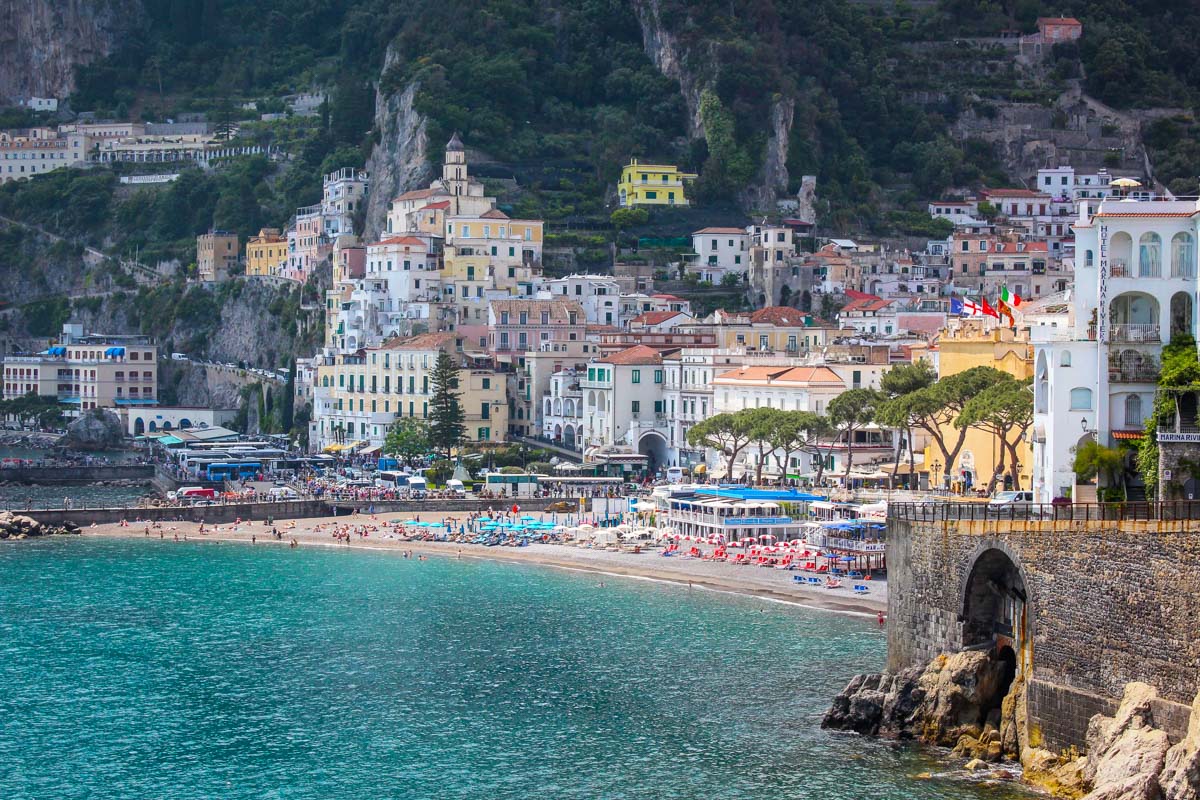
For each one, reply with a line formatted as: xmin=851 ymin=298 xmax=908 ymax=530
xmin=888 ymin=500 xmax=1200 ymax=522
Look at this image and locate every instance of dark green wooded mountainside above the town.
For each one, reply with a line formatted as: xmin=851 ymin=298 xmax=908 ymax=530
xmin=46 ymin=0 xmax=1200 ymax=227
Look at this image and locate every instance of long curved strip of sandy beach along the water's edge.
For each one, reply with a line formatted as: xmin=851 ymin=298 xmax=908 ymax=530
xmin=83 ymin=513 xmax=887 ymax=616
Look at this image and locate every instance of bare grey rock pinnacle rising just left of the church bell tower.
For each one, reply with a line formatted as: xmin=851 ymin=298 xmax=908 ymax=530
xmin=365 ymin=48 xmax=432 ymax=241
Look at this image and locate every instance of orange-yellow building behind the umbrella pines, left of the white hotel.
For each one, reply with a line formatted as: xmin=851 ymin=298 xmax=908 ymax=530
xmin=925 ymin=318 xmax=1033 ymax=491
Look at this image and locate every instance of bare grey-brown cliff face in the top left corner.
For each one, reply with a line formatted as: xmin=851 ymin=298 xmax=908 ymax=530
xmin=0 ymin=0 xmax=144 ymax=101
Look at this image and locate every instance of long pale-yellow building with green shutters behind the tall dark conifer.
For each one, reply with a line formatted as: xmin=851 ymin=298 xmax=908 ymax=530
xmin=308 ymin=333 xmax=509 ymax=449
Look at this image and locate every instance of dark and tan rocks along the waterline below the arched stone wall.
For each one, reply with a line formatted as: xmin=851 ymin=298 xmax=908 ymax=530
xmin=821 ymin=650 xmax=1200 ymax=800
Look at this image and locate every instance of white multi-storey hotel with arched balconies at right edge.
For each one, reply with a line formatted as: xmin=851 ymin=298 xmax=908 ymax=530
xmin=1031 ymin=198 xmax=1200 ymax=503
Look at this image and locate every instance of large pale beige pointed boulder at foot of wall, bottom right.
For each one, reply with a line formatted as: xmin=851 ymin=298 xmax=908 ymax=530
xmin=1085 ymin=682 xmax=1170 ymax=800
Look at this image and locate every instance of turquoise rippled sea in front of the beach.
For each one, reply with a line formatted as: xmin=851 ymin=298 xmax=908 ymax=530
xmin=0 ymin=540 xmax=1025 ymax=800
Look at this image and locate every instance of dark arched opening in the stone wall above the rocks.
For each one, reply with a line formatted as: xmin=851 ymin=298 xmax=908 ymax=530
xmin=960 ymin=548 xmax=1026 ymax=663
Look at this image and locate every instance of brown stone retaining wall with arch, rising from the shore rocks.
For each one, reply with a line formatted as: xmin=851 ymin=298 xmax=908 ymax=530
xmin=888 ymin=518 xmax=1200 ymax=750
